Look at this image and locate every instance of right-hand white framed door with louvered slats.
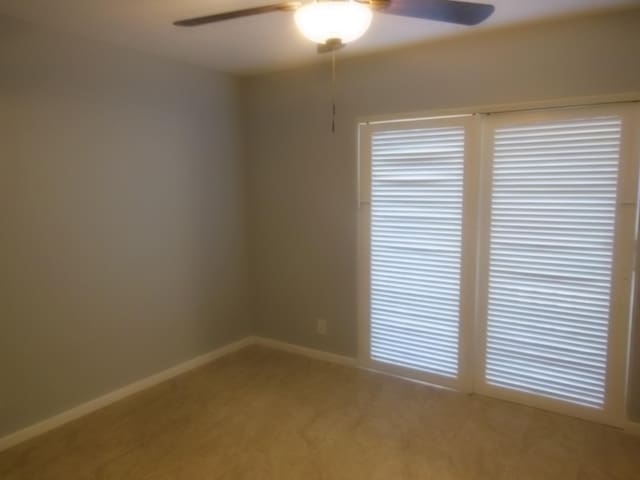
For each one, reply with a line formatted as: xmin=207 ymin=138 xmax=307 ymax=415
xmin=476 ymin=106 xmax=637 ymax=419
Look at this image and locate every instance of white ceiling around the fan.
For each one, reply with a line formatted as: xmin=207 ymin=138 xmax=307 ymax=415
xmin=0 ymin=0 xmax=640 ymax=73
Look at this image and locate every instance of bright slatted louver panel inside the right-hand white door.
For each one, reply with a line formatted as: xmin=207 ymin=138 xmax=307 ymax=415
xmin=485 ymin=116 xmax=621 ymax=409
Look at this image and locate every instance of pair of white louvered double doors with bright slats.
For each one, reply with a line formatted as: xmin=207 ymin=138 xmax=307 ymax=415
xmin=359 ymin=105 xmax=639 ymax=422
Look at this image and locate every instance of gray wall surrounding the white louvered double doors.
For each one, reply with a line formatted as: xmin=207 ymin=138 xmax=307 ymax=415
xmin=241 ymin=10 xmax=640 ymax=368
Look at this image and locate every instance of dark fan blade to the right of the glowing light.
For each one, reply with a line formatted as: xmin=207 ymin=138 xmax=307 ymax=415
xmin=380 ymin=0 xmax=495 ymax=25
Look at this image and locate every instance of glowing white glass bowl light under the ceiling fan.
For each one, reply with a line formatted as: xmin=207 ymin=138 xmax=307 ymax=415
xmin=295 ymin=0 xmax=373 ymax=44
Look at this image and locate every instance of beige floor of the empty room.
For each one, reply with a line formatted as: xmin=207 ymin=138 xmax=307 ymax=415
xmin=0 ymin=347 xmax=640 ymax=480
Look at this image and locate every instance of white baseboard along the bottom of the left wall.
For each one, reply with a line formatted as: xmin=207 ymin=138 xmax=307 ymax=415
xmin=0 ymin=337 xmax=254 ymax=452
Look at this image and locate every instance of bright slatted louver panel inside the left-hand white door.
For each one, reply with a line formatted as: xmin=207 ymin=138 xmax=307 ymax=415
xmin=369 ymin=126 xmax=465 ymax=378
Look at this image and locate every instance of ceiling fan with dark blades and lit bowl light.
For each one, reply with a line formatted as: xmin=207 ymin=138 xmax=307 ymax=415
xmin=174 ymin=0 xmax=494 ymax=53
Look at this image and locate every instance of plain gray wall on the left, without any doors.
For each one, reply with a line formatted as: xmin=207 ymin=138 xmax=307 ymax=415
xmin=0 ymin=17 xmax=250 ymax=436
